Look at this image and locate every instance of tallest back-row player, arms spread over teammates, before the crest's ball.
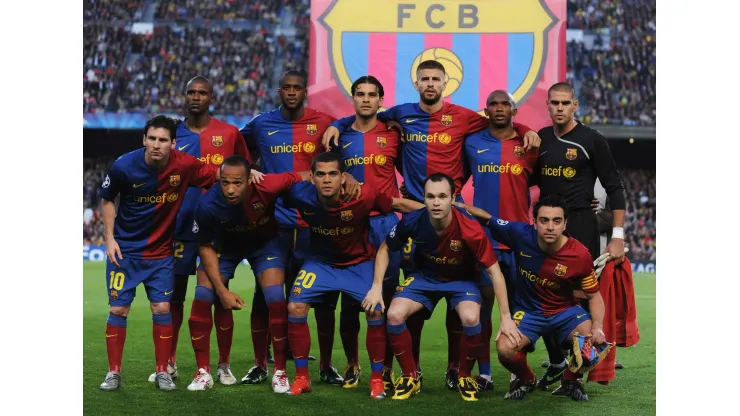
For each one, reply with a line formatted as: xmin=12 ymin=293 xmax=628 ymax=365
xmin=322 ymin=60 xmax=540 ymax=390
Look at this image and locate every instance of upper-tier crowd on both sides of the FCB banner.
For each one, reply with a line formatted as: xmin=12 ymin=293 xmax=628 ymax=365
xmin=83 ymin=0 xmax=656 ymax=125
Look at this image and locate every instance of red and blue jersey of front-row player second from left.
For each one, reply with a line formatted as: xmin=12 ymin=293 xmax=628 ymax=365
xmin=194 ymin=172 xmax=302 ymax=253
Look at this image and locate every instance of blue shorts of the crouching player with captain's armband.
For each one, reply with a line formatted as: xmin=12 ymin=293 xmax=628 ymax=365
xmin=511 ymin=305 xmax=591 ymax=350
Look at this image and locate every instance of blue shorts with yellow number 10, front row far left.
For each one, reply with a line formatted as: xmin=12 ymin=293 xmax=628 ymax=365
xmin=105 ymin=257 xmax=175 ymax=306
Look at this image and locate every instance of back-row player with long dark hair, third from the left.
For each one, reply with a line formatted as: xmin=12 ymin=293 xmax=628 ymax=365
xmin=333 ymin=75 xmax=401 ymax=390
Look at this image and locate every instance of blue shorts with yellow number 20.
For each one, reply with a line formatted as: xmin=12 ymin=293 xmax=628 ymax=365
xmin=290 ymin=259 xmax=380 ymax=310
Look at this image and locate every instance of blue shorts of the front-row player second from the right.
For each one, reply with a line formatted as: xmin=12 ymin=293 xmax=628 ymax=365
xmin=393 ymin=272 xmax=481 ymax=315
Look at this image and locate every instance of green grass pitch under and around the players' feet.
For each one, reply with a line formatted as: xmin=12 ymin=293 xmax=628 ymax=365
xmin=83 ymin=262 xmax=656 ymax=415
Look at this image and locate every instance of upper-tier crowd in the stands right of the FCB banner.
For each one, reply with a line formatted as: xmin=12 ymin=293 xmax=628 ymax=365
xmin=567 ymin=0 xmax=656 ymax=125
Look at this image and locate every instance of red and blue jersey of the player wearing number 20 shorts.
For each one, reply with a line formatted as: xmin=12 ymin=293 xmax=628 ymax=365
xmin=284 ymin=183 xmax=393 ymax=267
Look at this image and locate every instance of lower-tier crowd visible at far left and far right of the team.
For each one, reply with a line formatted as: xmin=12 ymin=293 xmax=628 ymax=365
xmin=82 ymin=157 xmax=656 ymax=260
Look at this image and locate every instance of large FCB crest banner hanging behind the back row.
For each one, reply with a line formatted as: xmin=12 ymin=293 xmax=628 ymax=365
xmin=308 ymin=0 xmax=566 ymax=129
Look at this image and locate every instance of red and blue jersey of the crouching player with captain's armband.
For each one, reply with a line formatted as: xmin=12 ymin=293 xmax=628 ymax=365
xmin=488 ymin=218 xmax=599 ymax=316
